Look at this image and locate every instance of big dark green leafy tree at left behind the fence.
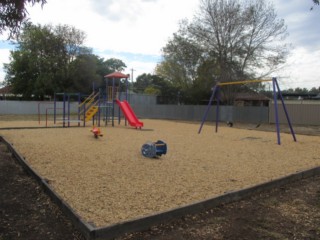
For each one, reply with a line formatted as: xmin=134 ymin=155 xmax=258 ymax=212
xmin=5 ymin=23 xmax=90 ymax=99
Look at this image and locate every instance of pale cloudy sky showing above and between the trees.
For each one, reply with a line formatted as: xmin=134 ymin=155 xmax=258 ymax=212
xmin=0 ymin=0 xmax=320 ymax=89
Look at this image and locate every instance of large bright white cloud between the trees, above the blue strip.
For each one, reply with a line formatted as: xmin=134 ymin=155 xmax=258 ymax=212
xmin=29 ymin=0 xmax=198 ymax=54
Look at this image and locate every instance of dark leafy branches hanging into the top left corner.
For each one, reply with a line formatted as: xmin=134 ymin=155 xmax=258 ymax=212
xmin=0 ymin=0 xmax=47 ymax=38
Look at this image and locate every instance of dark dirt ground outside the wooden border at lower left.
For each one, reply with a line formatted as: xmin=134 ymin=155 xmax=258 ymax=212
xmin=0 ymin=142 xmax=84 ymax=240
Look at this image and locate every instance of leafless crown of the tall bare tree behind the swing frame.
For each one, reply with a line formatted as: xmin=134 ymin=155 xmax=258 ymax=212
xmin=188 ymin=0 xmax=288 ymax=81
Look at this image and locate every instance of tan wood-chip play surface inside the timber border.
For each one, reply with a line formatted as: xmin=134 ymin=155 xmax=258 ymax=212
xmin=0 ymin=119 xmax=320 ymax=226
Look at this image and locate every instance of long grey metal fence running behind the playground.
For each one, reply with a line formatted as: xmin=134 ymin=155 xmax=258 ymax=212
xmin=0 ymin=95 xmax=320 ymax=125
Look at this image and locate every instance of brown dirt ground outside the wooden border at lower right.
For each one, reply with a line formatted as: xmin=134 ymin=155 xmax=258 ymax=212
xmin=116 ymin=176 xmax=320 ymax=240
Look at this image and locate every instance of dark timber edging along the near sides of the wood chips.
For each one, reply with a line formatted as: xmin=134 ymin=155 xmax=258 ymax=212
xmin=0 ymin=136 xmax=320 ymax=239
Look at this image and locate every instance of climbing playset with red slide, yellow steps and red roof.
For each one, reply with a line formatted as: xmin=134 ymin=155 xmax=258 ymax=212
xmin=50 ymin=72 xmax=143 ymax=129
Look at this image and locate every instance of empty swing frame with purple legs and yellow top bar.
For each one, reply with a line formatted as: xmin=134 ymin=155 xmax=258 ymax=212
xmin=198 ymin=78 xmax=297 ymax=145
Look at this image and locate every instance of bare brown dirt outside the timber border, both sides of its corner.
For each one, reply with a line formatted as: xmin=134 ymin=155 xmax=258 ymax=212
xmin=0 ymin=137 xmax=320 ymax=240
